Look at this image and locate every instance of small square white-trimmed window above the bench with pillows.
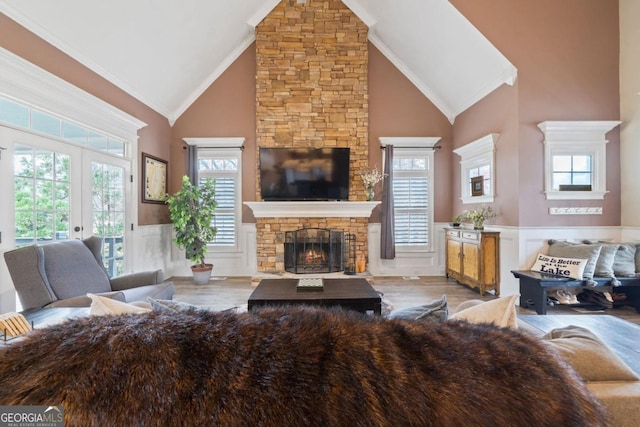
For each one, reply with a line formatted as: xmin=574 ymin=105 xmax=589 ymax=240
xmin=538 ymin=121 xmax=620 ymax=200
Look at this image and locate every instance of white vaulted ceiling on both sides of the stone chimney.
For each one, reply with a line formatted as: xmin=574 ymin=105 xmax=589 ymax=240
xmin=0 ymin=0 xmax=517 ymax=123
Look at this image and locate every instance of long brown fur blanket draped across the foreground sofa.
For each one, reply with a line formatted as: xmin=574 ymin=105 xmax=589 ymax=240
xmin=0 ymin=307 xmax=604 ymax=427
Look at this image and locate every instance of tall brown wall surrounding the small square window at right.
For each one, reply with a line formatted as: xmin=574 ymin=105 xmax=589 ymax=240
xmin=451 ymin=0 xmax=620 ymax=226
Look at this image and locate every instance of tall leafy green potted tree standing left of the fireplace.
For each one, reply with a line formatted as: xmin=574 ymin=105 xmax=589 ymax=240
xmin=165 ymin=175 xmax=218 ymax=284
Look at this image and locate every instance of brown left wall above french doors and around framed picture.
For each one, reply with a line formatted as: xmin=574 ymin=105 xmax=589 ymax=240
xmin=0 ymin=14 xmax=171 ymax=225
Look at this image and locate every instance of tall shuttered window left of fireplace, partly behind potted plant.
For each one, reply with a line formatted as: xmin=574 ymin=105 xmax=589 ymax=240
xmin=185 ymin=138 xmax=244 ymax=251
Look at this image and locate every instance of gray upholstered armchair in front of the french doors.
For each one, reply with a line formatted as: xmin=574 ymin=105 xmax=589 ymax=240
xmin=4 ymin=236 xmax=174 ymax=310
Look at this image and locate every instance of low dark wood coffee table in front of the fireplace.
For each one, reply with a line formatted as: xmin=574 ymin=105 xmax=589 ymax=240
xmin=248 ymin=278 xmax=382 ymax=316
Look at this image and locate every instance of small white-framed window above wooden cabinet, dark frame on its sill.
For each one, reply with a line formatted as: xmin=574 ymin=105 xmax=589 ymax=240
xmin=453 ymin=133 xmax=500 ymax=204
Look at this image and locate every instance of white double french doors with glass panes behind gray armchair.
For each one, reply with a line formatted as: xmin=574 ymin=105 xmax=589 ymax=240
xmin=0 ymin=127 xmax=131 ymax=276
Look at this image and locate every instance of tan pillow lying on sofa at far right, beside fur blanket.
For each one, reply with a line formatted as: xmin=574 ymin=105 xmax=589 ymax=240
xmin=542 ymin=326 xmax=640 ymax=381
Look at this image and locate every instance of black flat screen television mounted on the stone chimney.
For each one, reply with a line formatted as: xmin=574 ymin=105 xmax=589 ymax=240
xmin=260 ymin=148 xmax=349 ymax=201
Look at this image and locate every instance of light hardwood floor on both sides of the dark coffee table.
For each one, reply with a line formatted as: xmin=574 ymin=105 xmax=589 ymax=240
xmin=169 ymin=276 xmax=640 ymax=325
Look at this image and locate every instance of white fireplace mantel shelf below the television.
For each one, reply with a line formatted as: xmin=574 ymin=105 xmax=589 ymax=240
xmin=244 ymin=201 xmax=380 ymax=218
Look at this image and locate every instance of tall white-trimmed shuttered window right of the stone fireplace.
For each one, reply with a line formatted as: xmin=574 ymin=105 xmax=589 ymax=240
xmin=380 ymin=138 xmax=440 ymax=252
